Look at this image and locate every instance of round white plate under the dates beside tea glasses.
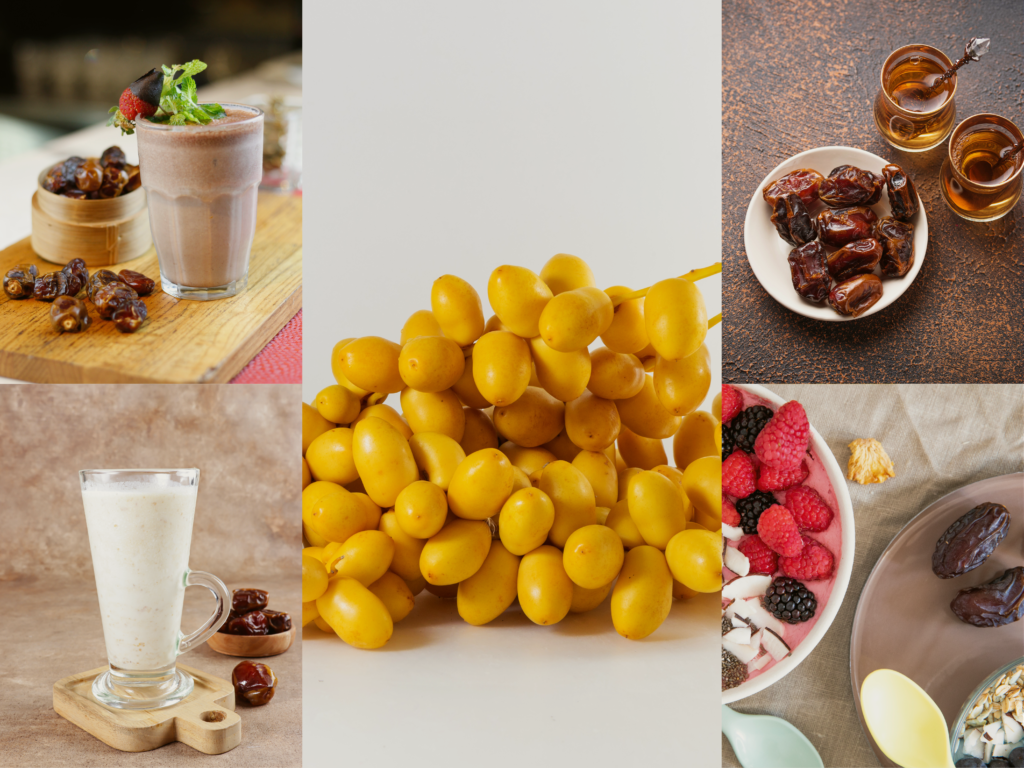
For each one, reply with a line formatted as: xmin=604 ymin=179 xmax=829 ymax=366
xmin=743 ymin=146 xmax=928 ymax=322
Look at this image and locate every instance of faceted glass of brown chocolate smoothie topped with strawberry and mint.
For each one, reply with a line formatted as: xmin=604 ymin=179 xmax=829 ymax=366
xmin=136 ymin=104 xmax=263 ymax=301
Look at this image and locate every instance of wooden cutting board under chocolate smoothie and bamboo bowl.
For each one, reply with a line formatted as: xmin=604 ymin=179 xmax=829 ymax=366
xmin=0 ymin=193 xmax=302 ymax=383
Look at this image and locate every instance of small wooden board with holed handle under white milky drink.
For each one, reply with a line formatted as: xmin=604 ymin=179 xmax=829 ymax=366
xmin=53 ymin=665 xmax=242 ymax=755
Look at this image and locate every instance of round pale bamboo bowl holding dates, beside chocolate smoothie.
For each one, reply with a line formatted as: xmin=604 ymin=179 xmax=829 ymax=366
xmin=32 ymin=168 xmax=153 ymax=267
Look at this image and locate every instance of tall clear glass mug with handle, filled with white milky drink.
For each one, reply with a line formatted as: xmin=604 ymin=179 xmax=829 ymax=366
xmin=79 ymin=469 xmax=230 ymax=710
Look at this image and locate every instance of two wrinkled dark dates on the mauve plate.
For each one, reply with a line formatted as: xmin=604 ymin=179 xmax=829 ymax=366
xmin=932 ymin=502 xmax=1024 ymax=627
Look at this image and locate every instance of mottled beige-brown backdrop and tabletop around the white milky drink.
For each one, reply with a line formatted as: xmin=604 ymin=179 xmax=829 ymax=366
xmin=0 ymin=385 xmax=302 ymax=768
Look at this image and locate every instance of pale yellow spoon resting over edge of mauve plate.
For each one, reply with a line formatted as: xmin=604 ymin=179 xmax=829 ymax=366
xmin=860 ymin=670 xmax=955 ymax=768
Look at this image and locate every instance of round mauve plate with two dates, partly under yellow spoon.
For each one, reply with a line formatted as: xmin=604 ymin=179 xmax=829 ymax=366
xmin=850 ymin=473 xmax=1024 ymax=766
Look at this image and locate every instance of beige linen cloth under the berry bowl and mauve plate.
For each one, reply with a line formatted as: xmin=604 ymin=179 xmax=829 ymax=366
xmin=722 ymin=384 xmax=1024 ymax=768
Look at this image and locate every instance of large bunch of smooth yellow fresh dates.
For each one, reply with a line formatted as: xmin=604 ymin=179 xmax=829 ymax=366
xmin=302 ymin=254 xmax=722 ymax=648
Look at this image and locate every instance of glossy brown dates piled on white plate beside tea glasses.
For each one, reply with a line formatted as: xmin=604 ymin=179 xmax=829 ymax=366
xmin=761 ymin=164 xmax=918 ymax=317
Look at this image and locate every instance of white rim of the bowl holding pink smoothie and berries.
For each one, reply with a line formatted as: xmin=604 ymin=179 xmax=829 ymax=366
xmin=722 ymin=385 xmax=855 ymax=703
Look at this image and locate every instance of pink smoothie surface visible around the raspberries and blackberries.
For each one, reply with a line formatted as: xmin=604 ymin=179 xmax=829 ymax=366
xmin=722 ymin=387 xmax=843 ymax=680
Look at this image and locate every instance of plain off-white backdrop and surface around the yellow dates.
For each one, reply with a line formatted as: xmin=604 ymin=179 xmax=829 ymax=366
xmin=303 ymin=0 xmax=721 ymax=766
